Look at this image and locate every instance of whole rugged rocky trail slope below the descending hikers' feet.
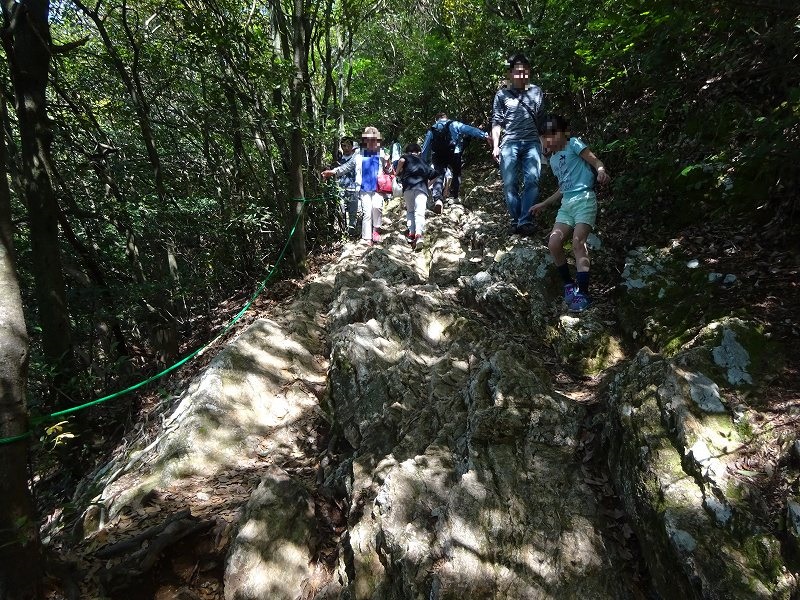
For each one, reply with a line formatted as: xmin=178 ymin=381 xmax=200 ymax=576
xmin=47 ymin=176 xmax=800 ymax=600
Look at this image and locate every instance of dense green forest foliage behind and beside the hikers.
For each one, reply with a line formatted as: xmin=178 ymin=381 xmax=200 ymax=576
xmin=7 ymin=0 xmax=800 ymax=422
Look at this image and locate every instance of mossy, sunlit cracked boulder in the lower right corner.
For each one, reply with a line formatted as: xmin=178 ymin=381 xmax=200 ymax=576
xmin=604 ymin=346 xmax=796 ymax=599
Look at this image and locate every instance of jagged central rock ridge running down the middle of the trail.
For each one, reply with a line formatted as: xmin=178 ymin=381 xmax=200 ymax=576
xmin=326 ymin=208 xmax=624 ymax=599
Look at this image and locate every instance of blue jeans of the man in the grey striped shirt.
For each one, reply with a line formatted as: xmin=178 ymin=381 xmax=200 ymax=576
xmin=500 ymin=139 xmax=542 ymax=226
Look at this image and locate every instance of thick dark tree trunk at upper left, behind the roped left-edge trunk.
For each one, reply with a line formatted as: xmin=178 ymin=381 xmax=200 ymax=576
xmin=3 ymin=0 xmax=74 ymax=404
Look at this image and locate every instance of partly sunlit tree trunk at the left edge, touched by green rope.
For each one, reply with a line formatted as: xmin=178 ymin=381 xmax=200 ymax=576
xmin=0 ymin=92 xmax=41 ymax=600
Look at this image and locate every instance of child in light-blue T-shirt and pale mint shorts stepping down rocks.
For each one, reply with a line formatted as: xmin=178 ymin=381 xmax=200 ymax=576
xmin=530 ymin=115 xmax=611 ymax=312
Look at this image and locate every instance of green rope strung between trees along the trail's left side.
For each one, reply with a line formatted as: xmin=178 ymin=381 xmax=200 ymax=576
xmin=0 ymin=194 xmax=330 ymax=446
